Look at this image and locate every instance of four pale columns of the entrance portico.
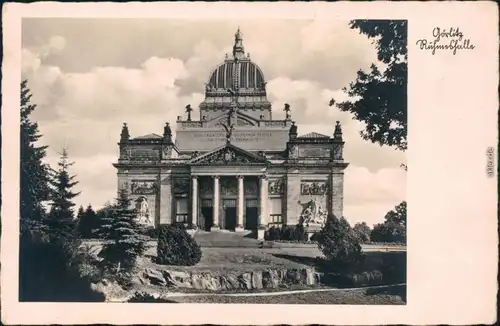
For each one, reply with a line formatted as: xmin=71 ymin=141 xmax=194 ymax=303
xmin=191 ymin=175 xmax=268 ymax=229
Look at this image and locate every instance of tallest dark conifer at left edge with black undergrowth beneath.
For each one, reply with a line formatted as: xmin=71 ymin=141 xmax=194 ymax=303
xmin=19 ymin=81 xmax=104 ymax=301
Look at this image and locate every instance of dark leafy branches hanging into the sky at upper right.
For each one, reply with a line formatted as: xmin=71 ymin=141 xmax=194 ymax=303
xmin=337 ymin=20 xmax=408 ymax=151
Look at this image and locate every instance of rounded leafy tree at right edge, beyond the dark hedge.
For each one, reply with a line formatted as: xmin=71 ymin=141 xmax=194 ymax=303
xmin=370 ymin=201 xmax=406 ymax=242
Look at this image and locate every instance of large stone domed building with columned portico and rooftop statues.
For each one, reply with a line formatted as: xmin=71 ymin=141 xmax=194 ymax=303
xmin=113 ymin=29 xmax=348 ymax=238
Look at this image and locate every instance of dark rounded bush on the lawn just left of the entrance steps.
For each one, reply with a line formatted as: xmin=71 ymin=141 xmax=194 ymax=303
xmin=156 ymin=225 xmax=201 ymax=266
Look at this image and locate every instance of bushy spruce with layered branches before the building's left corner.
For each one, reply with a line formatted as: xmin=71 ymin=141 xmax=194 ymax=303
xmin=99 ymin=189 xmax=148 ymax=273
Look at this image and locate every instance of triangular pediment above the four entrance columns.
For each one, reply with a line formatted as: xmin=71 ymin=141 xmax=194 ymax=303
xmin=189 ymin=144 xmax=267 ymax=165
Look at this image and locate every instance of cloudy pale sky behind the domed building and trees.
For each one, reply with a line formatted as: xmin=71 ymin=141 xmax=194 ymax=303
xmin=22 ymin=18 xmax=406 ymax=225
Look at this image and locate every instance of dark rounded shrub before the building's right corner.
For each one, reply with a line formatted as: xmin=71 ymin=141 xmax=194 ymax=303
xmin=317 ymin=215 xmax=362 ymax=268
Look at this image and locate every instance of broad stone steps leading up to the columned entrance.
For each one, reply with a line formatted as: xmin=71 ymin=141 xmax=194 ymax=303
xmin=193 ymin=230 xmax=262 ymax=248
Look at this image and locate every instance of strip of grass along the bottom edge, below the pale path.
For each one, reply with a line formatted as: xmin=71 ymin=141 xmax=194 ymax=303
xmin=164 ymin=285 xmax=406 ymax=305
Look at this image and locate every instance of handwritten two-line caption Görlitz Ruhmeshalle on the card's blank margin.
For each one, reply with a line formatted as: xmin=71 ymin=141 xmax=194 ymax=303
xmin=416 ymin=27 xmax=475 ymax=55
